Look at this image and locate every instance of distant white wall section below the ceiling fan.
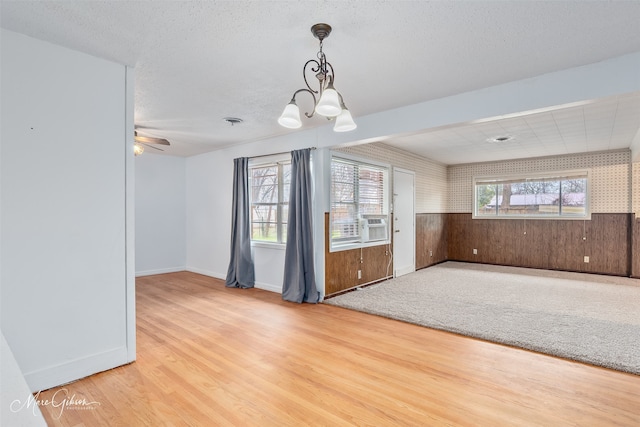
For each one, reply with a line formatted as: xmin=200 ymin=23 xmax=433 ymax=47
xmin=135 ymin=154 xmax=187 ymax=276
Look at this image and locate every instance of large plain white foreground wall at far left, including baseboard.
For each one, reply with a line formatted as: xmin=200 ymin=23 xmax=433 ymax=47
xmin=0 ymin=30 xmax=135 ymax=391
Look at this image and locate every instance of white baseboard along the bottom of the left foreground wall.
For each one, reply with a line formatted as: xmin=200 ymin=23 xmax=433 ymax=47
xmin=24 ymin=346 xmax=135 ymax=393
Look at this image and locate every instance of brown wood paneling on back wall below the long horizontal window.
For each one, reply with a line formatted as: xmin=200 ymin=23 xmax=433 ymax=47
xmin=446 ymin=213 xmax=640 ymax=276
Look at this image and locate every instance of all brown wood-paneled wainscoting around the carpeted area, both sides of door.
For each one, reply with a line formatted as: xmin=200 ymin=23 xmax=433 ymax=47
xmin=325 ymin=213 xmax=640 ymax=295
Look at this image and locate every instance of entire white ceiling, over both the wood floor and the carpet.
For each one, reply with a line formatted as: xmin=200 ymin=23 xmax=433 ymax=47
xmin=0 ymin=0 xmax=640 ymax=164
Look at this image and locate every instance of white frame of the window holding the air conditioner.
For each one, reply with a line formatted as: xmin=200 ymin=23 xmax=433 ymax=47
xmin=327 ymin=151 xmax=391 ymax=252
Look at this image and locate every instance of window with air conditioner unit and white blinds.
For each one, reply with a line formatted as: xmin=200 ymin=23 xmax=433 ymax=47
xmin=329 ymin=156 xmax=389 ymax=249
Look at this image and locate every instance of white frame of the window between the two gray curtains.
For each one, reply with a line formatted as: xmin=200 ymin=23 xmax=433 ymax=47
xmin=249 ymin=155 xmax=291 ymax=249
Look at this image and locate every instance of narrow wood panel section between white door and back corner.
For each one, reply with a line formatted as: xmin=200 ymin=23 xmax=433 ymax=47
xmin=416 ymin=213 xmax=447 ymax=269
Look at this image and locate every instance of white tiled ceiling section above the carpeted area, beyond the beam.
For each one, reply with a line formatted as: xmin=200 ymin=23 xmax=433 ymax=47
xmin=384 ymin=92 xmax=640 ymax=165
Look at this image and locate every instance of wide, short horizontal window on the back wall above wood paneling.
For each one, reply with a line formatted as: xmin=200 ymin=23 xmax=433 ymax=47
xmin=474 ymin=171 xmax=589 ymax=219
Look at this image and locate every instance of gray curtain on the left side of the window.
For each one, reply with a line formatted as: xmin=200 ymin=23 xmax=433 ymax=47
xmin=225 ymin=157 xmax=256 ymax=288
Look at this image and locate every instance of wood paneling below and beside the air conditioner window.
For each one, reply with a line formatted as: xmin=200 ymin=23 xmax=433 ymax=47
xmin=324 ymin=213 xmax=393 ymax=295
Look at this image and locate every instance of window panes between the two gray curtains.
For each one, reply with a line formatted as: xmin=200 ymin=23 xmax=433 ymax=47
xmin=249 ymin=160 xmax=291 ymax=243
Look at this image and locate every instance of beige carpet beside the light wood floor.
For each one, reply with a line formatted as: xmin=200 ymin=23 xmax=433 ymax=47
xmin=324 ymin=262 xmax=640 ymax=375
